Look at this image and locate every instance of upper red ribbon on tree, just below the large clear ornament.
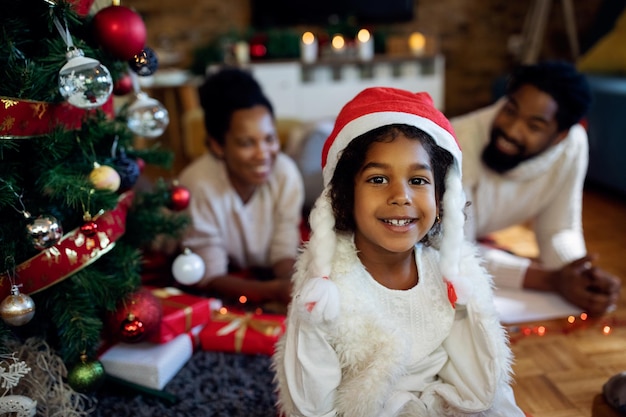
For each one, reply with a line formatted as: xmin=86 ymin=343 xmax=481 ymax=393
xmin=0 ymin=97 xmax=114 ymax=139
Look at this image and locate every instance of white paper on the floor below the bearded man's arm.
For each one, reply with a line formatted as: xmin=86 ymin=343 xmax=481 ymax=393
xmin=494 ymin=288 xmax=583 ymax=324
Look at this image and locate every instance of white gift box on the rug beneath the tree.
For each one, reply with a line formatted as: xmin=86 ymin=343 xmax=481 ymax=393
xmin=99 ymin=327 xmax=201 ymax=390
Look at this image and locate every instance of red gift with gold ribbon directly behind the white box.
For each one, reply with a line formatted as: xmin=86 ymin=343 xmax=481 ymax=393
xmin=146 ymin=287 xmax=222 ymax=343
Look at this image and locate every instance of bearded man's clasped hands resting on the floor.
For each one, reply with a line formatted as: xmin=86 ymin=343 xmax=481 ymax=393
xmin=553 ymin=256 xmax=621 ymax=316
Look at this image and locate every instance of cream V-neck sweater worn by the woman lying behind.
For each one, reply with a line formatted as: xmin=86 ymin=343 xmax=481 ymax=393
xmin=178 ymin=153 xmax=304 ymax=277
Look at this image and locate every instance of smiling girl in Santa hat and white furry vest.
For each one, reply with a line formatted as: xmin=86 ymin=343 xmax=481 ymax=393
xmin=274 ymin=88 xmax=524 ymax=417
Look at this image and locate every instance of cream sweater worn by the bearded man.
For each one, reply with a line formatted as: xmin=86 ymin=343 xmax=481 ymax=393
xmin=451 ymin=100 xmax=588 ymax=288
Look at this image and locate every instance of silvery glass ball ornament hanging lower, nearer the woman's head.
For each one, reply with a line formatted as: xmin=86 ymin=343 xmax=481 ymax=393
xmin=127 ymin=91 xmax=170 ymax=139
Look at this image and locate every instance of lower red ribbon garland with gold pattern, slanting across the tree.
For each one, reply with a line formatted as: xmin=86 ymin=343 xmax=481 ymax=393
xmin=0 ymin=191 xmax=134 ymax=300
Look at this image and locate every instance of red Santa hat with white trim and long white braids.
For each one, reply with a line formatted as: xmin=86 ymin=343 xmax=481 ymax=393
xmin=299 ymin=87 xmax=469 ymax=320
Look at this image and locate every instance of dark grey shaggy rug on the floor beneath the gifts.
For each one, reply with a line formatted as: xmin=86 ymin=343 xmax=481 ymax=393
xmin=92 ymin=351 xmax=277 ymax=417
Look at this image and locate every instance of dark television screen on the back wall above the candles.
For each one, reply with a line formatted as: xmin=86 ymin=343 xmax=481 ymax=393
xmin=251 ymin=0 xmax=415 ymax=28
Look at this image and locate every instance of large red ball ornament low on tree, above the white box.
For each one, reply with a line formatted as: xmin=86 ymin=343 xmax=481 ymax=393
xmin=108 ymin=288 xmax=163 ymax=343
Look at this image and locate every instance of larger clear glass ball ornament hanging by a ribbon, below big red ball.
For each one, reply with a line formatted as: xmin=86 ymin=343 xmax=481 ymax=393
xmin=59 ymin=48 xmax=113 ymax=109
